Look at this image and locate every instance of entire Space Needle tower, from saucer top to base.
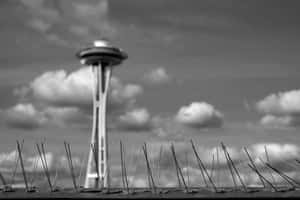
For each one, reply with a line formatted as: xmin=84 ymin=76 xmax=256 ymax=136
xmin=76 ymin=40 xmax=128 ymax=189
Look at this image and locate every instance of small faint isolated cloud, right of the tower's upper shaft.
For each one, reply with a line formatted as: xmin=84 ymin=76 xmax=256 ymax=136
xmin=143 ymin=67 xmax=171 ymax=84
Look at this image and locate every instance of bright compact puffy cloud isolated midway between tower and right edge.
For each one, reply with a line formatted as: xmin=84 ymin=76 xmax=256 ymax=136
xmin=175 ymin=102 xmax=223 ymax=128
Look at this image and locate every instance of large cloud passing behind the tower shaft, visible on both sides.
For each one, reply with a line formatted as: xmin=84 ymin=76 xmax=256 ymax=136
xmin=22 ymin=67 xmax=143 ymax=110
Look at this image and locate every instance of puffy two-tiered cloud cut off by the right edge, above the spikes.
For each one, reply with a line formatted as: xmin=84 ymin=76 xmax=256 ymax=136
xmin=256 ymin=90 xmax=300 ymax=128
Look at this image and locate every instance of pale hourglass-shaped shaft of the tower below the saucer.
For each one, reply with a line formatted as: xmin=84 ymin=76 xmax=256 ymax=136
xmin=84 ymin=63 xmax=112 ymax=188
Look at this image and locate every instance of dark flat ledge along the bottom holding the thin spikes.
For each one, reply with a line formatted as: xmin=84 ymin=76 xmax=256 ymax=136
xmin=0 ymin=188 xmax=300 ymax=199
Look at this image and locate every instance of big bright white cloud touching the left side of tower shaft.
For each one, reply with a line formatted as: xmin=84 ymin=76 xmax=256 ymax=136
xmin=30 ymin=68 xmax=93 ymax=108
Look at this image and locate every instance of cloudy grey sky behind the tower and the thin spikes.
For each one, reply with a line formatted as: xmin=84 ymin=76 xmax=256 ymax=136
xmin=0 ymin=0 xmax=300 ymax=186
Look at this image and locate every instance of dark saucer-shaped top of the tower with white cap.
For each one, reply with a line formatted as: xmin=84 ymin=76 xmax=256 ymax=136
xmin=76 ymin=40 xmax=128 ymax=66
